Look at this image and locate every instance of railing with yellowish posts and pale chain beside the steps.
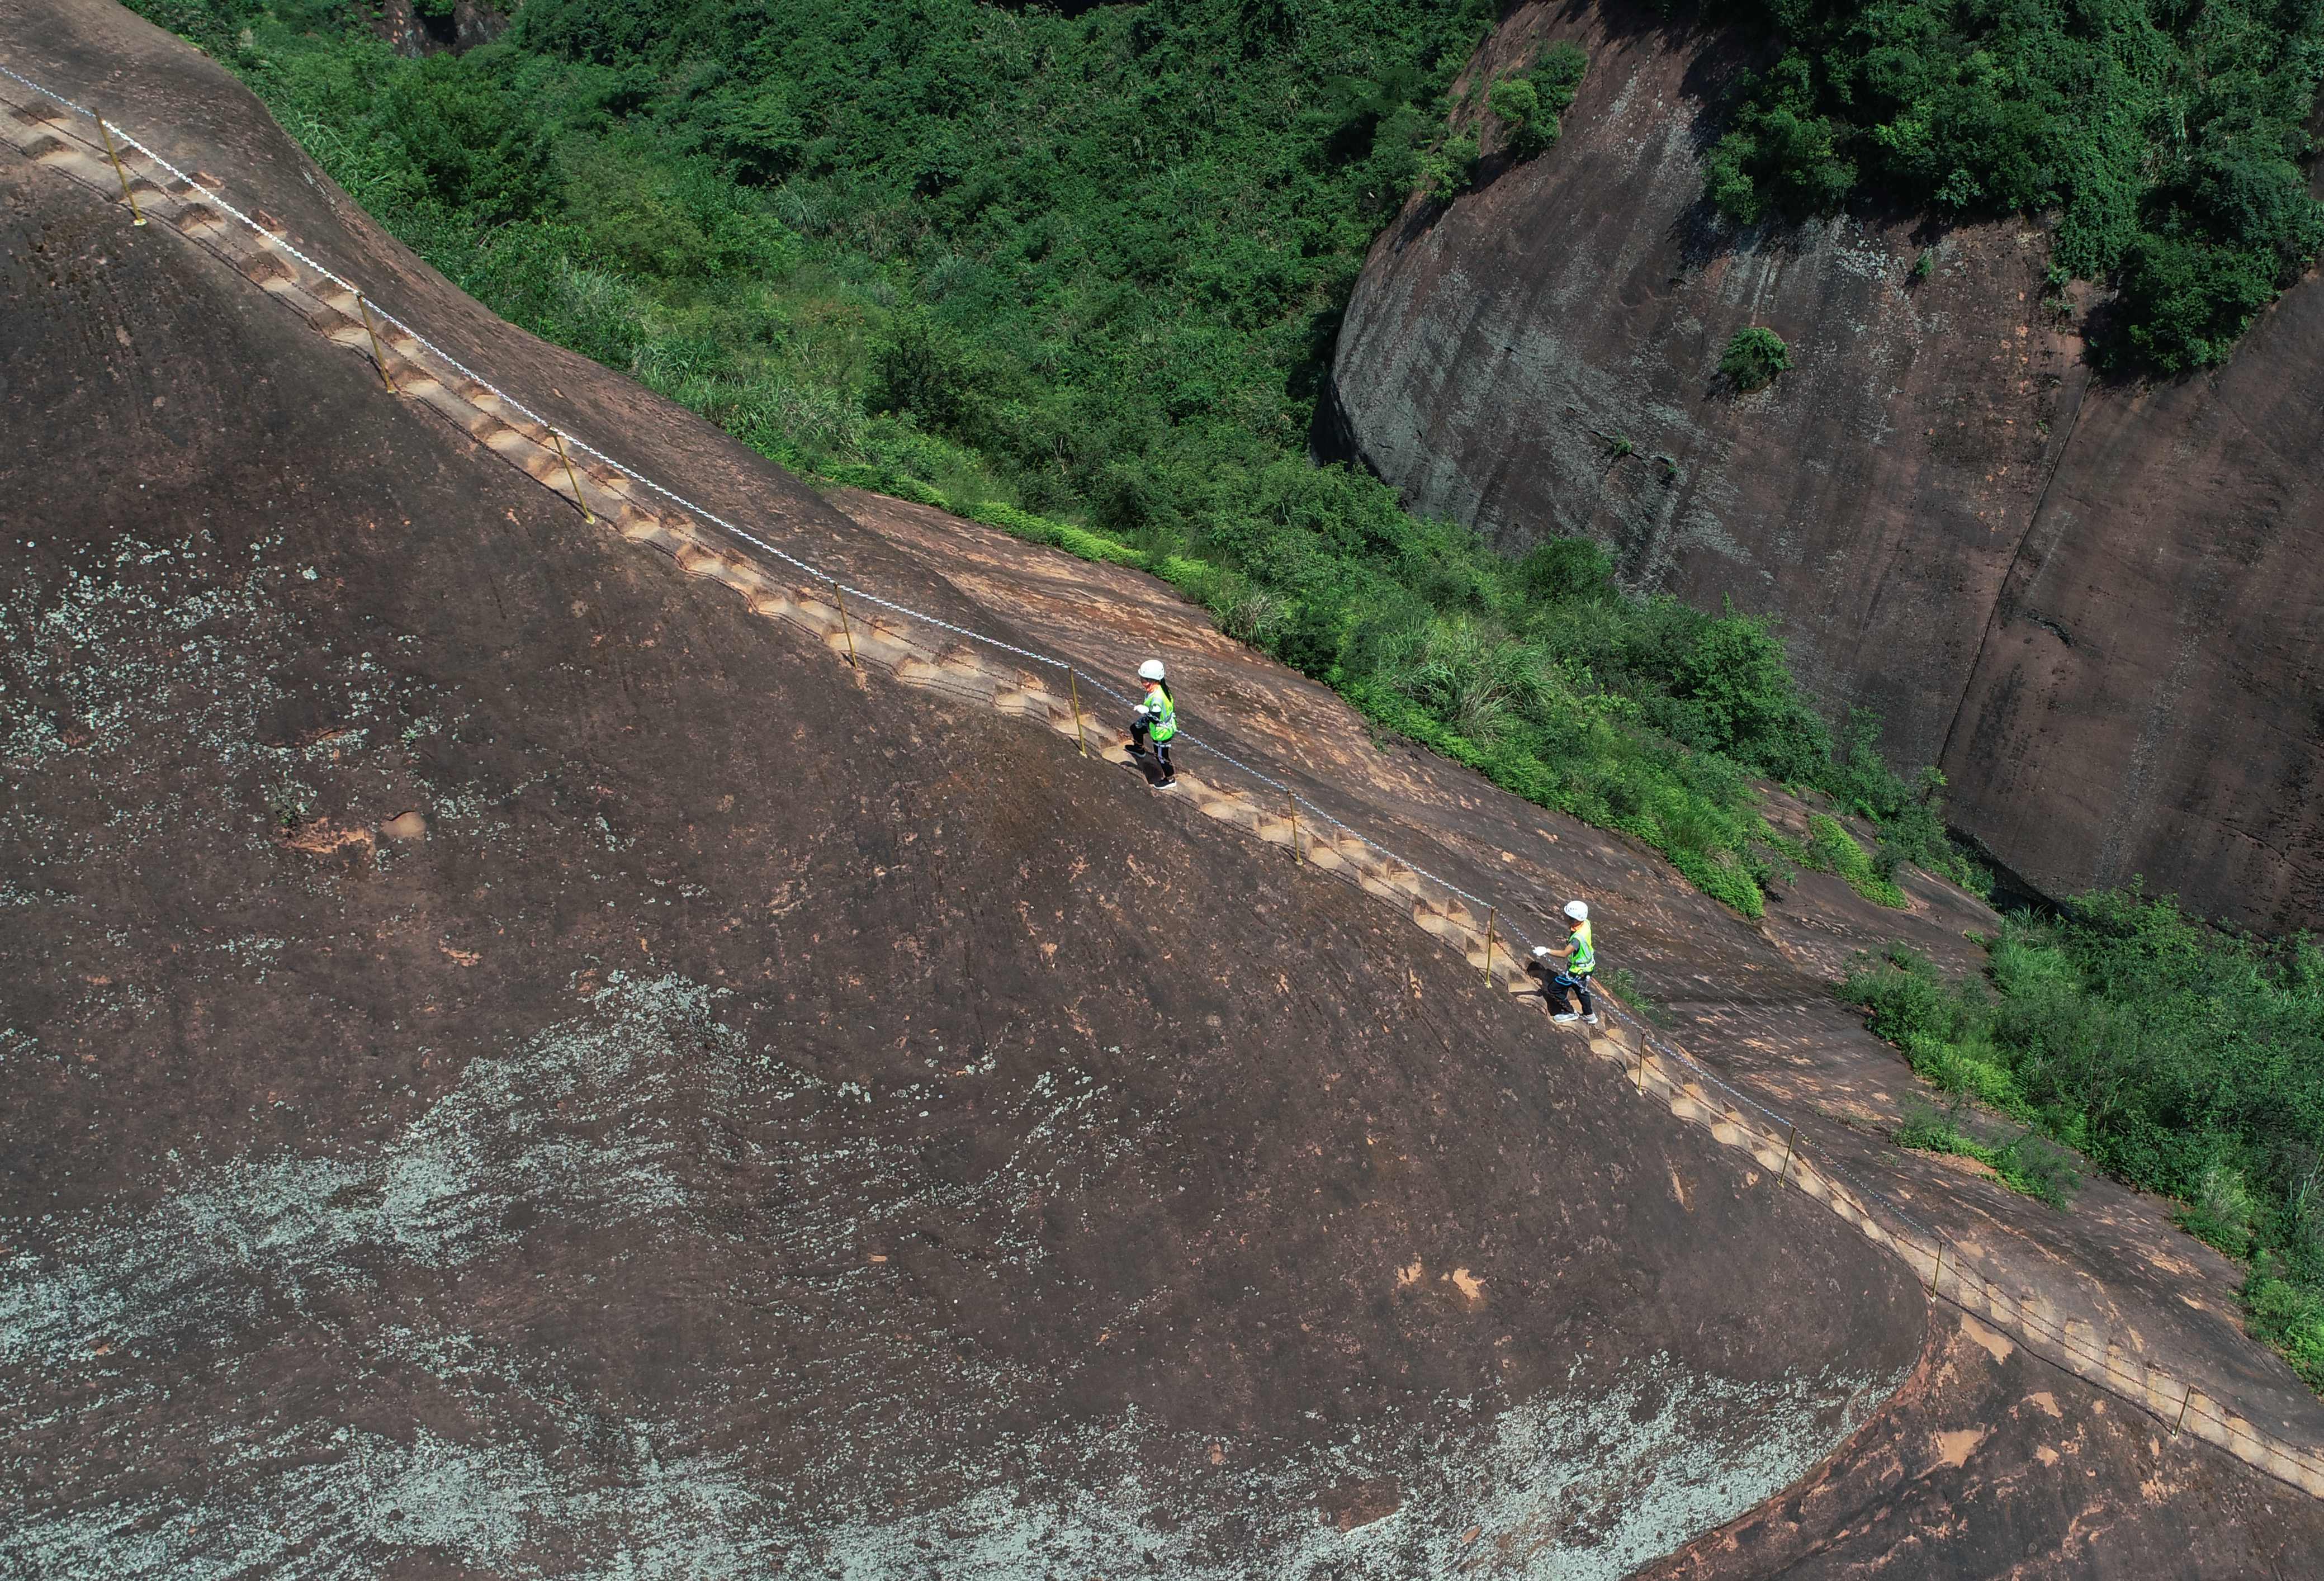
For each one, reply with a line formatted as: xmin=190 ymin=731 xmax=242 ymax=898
xmin=13 ymin=65 xmax=2324 ymax=1497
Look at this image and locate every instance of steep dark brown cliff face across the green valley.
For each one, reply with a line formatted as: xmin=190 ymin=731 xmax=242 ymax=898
xmin=1329 ymin=4 xmax=2324 ymax=927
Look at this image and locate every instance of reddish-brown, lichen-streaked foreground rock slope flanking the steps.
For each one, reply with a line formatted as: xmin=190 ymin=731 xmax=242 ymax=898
xmin=0 ymin=0 xmax=2324 ymax=1577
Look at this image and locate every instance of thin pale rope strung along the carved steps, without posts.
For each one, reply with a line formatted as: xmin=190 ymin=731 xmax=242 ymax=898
xmin=0 ymin=63 xmax=2324 ymax=1497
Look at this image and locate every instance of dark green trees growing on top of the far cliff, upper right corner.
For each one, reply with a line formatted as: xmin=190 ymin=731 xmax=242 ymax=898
xmin=1708 ymin=0 xmax=2324 ymax=372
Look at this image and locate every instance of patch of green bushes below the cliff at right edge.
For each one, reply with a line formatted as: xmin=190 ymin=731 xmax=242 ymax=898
xmin=1843 ymin=893 xmax=2324 ymax=1388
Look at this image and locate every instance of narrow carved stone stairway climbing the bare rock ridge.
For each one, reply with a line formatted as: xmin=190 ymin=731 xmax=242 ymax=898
xmin=13 ymin=74 xmax=2324 ymax=1497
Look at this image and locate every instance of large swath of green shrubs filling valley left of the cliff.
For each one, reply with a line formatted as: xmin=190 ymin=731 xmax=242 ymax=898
xmin=127 ymin=0 xmax=1973 ymax=913
